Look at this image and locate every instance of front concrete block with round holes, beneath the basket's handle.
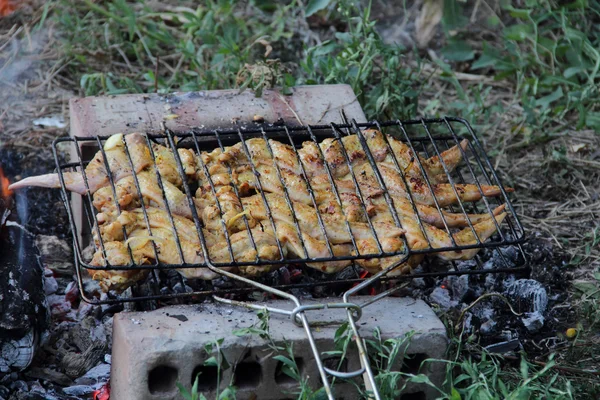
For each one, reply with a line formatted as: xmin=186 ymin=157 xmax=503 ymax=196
xmin=111 ymin=297 xmax=447 ymax=400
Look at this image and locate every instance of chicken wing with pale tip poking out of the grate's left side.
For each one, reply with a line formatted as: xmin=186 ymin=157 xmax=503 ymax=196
xmin=10 ymin=133 xmax=152 ymax=194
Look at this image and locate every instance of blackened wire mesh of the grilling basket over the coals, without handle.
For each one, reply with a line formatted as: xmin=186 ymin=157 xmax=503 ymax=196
xmin=53 ymin=117 xmax=525 ymax=305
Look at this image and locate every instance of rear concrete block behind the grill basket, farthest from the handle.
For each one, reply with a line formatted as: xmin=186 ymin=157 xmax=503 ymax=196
xmin=69 ymin=84 xmax=366 ymax=136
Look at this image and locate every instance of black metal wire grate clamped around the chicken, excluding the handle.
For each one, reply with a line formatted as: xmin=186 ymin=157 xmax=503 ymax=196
xmin=53 ymin=117 xmax=524 ymax=303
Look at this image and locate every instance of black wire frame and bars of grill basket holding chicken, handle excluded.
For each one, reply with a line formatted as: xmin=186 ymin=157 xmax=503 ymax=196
xmin=53 ymin=117 xmax=526 ymax=304
